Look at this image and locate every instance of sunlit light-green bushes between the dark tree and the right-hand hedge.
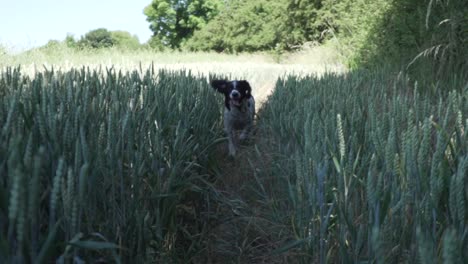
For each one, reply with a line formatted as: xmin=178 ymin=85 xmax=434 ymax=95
xmin=187 ymin=0 xmax=336 ymax=52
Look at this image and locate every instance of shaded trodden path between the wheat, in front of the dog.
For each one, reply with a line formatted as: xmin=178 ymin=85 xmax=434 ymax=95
xmin=203 ymin=144 xmax=283 ymax=263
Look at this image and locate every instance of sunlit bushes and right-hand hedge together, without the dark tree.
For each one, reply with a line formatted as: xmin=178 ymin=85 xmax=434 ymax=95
xmin=181 ymin=0 xmax=468 ymax=78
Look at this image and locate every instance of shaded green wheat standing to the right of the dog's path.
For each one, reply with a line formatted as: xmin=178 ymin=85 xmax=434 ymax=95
xmin=256 ymin=70 xmax=468 ymax=263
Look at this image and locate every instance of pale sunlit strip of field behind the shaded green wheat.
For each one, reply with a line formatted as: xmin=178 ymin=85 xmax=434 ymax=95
xmin=0 ymin=47 xmax=345 ymax=101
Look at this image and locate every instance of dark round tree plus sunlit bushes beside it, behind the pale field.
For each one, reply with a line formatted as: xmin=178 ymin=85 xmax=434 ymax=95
xmin=144 ymin=0 xmax=329 ymax=52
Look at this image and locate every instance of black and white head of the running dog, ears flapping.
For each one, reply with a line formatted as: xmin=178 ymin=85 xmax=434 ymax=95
xmin=211 ymin=80 xmax=252 ymax=110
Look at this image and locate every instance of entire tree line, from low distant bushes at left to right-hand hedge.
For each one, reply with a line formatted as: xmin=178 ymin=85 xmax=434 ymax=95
xmin=41 ymin=0 xmax=468 ymax=73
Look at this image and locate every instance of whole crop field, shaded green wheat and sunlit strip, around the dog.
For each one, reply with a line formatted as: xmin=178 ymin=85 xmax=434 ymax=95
xmin=0 ymin=48 xmax=468 ymax=263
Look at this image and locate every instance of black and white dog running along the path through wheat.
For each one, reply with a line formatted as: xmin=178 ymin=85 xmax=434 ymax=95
xmin=211 ymin=80 xmax=255 ymax=157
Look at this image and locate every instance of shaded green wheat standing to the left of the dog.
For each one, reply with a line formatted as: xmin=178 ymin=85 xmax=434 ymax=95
xmin=0 ymin=67 xmax=221 ymax=263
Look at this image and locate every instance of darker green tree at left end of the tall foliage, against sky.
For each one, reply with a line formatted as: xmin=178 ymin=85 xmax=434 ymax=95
xmin=144 ymin=0 xmax=223 ymax=48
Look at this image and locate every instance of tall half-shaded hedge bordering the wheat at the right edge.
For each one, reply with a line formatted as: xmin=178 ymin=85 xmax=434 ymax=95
xmin=319 ymin=0 xmax=468 ymax=79
